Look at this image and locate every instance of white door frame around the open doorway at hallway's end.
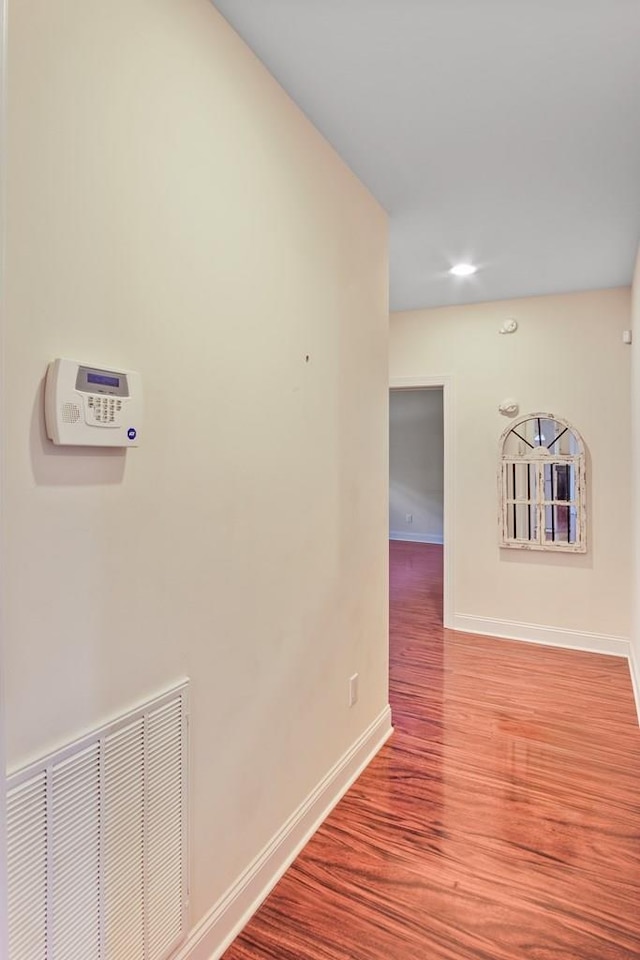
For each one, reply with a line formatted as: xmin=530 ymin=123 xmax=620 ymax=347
xmin=389 ymin=374 xmax=455 ymax=630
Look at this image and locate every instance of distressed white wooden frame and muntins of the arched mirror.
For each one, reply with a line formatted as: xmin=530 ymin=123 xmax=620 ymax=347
xmin=498 ymin=413 xmax=587 ymax=553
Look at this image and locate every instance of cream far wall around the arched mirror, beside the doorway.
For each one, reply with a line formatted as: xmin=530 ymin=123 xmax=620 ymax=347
xmin=390 ymin=289 xmax=631 ymax=652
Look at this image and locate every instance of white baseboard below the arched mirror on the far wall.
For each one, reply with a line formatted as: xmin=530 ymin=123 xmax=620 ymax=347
xmin=453 ymin=613 xmax=629 ymax=657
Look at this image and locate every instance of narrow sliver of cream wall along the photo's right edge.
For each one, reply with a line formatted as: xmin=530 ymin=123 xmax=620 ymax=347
xmin=630 ymin=247 xmax=640 ymax=719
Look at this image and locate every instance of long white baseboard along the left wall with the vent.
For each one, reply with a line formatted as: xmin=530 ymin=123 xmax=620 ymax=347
xmin=175 ymin=706 xmax=393 ymax=960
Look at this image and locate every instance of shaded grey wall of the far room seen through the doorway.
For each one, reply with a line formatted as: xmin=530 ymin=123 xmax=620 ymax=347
xmin=389 ymin=389 xmax=444 ymax=543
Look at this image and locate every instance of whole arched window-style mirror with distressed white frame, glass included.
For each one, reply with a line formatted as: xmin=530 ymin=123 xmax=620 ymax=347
xmin=499 ymin=413 xmax=587 ymax=553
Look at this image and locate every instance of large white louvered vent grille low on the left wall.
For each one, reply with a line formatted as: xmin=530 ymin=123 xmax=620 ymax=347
xmin=7 ymin=684 xmax=188 ymax=960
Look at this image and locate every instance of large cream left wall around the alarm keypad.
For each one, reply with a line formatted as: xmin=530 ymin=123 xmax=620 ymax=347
xmin=2 ymin=0 xmax=388 ymax=921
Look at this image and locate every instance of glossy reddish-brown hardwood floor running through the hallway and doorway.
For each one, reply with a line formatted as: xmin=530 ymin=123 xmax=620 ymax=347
xmin=225 ymin=543 xmax=640 ymax=960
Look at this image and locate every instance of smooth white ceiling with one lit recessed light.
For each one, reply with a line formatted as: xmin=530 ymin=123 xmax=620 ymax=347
xmin=214 ymin=0 xmax=640 ymax=309
